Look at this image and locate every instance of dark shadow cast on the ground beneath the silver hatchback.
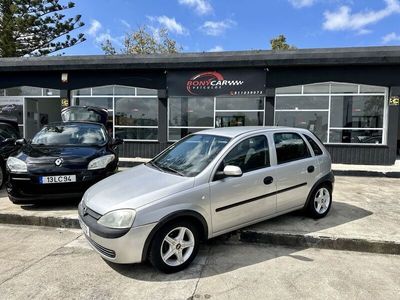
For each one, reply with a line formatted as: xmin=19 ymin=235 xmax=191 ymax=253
xmin=105 ymin=202 xmax=372 ymax=281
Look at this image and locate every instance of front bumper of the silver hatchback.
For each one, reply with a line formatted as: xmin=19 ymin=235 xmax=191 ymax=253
xmin=79 ymin=216 xmax=156 ymax=264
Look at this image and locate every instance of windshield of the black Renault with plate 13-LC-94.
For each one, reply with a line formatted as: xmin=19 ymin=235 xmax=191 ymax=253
xmin=32 ymin=124 xmax=107 ymax=145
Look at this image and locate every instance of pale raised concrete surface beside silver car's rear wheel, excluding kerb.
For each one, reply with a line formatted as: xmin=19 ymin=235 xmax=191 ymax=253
xmin=244 ymin=176 xmax=400 ymax=243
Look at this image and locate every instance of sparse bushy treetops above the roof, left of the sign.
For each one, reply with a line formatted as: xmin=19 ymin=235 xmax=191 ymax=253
xmin=101 ymin=25 xmax=181 ymax=55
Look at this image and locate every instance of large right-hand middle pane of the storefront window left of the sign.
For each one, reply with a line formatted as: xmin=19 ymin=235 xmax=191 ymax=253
xmin=115 ymin=98 xmax=158 ymax=126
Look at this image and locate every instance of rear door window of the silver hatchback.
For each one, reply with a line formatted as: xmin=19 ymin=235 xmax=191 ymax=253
xmin=274 ymin=132 xmax=311 ymax=164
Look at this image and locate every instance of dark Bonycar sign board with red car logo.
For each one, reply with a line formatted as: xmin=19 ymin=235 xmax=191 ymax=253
xmin=167 ymin=69 xmax=266 ymax=97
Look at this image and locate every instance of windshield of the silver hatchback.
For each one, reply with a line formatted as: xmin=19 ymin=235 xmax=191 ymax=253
xmin=149 ymin=134 xmax=230 ymax=177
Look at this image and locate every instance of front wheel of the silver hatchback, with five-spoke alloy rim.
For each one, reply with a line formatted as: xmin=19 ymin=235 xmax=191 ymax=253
xmin=149 ymin=221 xmax=200 ymax=273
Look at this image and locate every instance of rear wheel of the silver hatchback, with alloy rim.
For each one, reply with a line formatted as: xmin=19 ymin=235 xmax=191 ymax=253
xmin=307 ymin=184 xmax=332 ymax=219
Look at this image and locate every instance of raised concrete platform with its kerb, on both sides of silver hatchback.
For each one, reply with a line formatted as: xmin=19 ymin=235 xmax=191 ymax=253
xmin=0 ymin=176 xmax=400 ymax=254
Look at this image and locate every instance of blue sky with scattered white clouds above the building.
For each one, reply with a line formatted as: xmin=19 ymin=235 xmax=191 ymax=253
xmin=64 ymin=0 xmax=400 ymax=55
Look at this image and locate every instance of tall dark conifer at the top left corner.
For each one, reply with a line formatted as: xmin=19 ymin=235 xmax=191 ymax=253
xmin=0 ymin=0 xmax=85 ymax=57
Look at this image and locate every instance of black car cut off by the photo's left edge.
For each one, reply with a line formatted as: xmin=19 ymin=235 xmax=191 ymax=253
xmin=0 ymin=118 xmax=21 ymax=188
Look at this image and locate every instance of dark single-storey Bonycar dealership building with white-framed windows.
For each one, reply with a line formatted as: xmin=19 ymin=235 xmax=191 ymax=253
xmin=0 ymin=47 xmax=400 ymax=165
